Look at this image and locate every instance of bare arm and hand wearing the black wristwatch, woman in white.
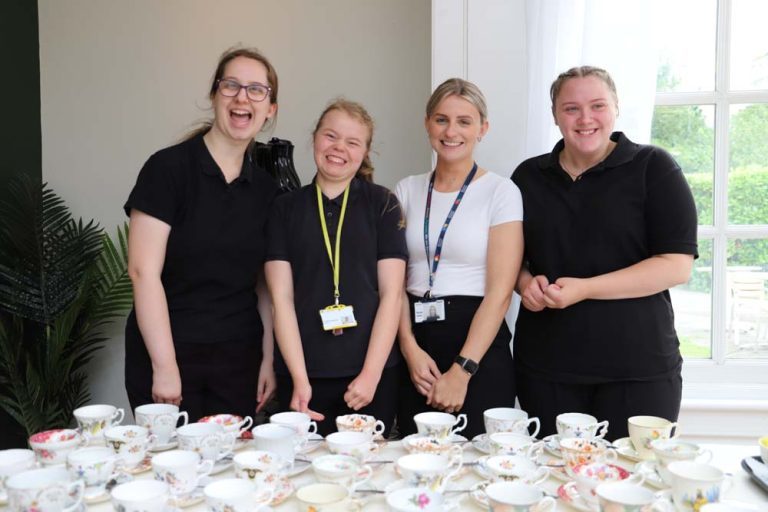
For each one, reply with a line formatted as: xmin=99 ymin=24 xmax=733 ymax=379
xmin=427 ymin=221 xmax=523 ymax=412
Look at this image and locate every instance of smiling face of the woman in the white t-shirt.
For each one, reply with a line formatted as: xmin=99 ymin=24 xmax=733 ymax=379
xmin=424 ymin=95 xmax=488 ymax=167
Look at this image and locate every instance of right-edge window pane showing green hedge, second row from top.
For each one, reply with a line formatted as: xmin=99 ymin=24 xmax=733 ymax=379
xmin=728 ymin=103 xmax=768 ymax=224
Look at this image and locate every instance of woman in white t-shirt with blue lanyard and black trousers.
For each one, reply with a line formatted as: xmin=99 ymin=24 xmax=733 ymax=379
xmin=395 ymin=78 xmax=523 ymax=436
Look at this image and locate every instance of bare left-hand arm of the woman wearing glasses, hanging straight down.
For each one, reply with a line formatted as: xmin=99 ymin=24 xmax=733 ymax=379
xmin=128 ymin=209 xmax=182 ymax=405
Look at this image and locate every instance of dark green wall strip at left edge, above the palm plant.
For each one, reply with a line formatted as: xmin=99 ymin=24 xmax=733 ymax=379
xmin=0 ymin=0 xmax=42 ymax=192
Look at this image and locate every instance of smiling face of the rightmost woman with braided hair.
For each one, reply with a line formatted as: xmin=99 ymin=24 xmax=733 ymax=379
xmin=554 ymin=76 xmax=618 ymax=159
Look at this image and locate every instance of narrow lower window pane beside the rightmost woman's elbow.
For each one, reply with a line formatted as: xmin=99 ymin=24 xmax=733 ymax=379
xmin=670 ymin=240 xmax=712 ymax=359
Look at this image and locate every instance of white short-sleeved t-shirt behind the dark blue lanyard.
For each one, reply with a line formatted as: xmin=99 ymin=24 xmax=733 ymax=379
xmin=395 ymin=172 xmax=523 ymax=297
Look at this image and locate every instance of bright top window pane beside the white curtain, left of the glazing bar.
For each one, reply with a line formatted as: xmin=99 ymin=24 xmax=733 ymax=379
xmin=654 ymin=0 xmax=717 ymax=92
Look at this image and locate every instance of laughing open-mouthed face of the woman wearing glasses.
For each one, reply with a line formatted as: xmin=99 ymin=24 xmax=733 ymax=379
xmin=211 ymin=56 xmax=277 ymax=142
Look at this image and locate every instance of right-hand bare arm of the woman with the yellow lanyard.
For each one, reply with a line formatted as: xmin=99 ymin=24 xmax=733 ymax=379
xmin=344 ymin=258 xmax=405 ymax=411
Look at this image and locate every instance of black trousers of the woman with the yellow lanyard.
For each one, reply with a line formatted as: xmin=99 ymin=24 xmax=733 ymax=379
xmin=277 ymin=365 xmax=400 ymax=438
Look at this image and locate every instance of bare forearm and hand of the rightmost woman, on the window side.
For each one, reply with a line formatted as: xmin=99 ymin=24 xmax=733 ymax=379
xmin=544 ymin=254 xmax=693 ymax=309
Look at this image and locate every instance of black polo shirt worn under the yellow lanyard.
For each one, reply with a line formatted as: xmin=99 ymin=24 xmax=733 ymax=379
xmin=266 ymin=178 xmax=408 ymax=378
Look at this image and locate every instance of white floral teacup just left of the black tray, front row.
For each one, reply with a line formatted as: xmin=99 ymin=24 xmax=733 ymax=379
xmin=667 ymin=461 xmax=731 ymax=512
